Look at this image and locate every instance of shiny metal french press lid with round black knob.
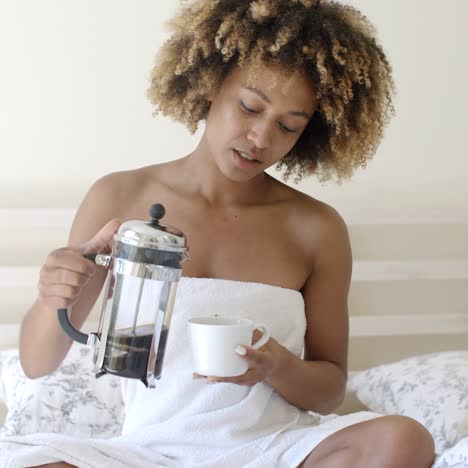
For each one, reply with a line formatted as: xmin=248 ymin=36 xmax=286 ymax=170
xmin=115 ymin=204 xmax=187 ymax=252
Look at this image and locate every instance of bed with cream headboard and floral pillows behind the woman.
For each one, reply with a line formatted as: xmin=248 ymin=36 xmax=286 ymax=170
xmin=0 ymin=210 xmax=468 ymax=468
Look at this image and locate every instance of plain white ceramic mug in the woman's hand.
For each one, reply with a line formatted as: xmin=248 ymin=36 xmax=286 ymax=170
xmin=188 ymin=317 xmax=270 ymax=377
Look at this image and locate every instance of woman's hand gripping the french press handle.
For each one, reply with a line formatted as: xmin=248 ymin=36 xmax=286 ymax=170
xmin=38 ymin=219 xmax=121 ymax=310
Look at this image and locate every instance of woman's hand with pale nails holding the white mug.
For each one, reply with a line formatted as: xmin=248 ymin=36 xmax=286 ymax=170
xmin=193 ymin=330 xmax=288 ymax=387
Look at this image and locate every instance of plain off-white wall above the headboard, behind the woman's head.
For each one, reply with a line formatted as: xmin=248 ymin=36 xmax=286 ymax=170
xmin=0 ymin=0 xmax=468 ymax=222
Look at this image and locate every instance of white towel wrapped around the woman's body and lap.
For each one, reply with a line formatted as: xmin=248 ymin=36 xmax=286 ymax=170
xmin=0 ymin=278 xmax=378 ymax=468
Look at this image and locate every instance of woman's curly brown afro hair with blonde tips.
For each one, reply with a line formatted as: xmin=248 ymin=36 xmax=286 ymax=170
xmin=147 ymin=0 xmax=394 ymax=182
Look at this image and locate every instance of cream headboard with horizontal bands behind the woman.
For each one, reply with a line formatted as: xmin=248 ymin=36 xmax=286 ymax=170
xmin=0 ymin=209 xmax=468 ymax=369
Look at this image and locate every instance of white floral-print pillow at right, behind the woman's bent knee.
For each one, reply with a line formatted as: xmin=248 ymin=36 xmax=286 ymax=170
xmin=348 ymin=351 xmax=468 ymax=453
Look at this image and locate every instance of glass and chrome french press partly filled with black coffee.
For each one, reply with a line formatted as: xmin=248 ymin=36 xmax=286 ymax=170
xmin=58 ymin=204 xmax=190 ymax=388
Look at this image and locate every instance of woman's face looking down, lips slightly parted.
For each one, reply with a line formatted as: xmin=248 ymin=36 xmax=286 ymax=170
xmin=204 ymin=66 xmax=316 ymax=181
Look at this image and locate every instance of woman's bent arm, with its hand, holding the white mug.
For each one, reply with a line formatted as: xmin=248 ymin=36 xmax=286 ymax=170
xmin=201 ymin=210 xmax=352 ymax=414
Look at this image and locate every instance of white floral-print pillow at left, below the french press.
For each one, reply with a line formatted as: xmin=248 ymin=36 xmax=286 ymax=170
xmin=0 ymin=343 xmax=124 ymax=438
